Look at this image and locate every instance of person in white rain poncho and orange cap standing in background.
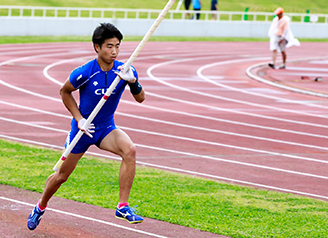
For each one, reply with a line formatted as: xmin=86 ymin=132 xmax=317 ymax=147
xmin=268 ymin=7 xmax=301 ymax=69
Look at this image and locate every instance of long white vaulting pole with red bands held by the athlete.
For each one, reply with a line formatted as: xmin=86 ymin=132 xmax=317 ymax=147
xmin=53 ymin=0 xmax=175 ymax=171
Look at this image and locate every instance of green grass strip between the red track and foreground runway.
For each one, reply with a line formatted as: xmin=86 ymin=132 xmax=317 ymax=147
xmin=0 ymin=140 xmax=328 ymax=238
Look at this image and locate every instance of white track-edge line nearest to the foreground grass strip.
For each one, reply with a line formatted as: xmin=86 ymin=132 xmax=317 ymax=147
xmin=0 ymin=134 xmax=328 ymax=199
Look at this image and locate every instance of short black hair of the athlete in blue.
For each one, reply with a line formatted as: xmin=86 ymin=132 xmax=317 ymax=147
xmin=92 ymin=23 xmax=123 ymax=53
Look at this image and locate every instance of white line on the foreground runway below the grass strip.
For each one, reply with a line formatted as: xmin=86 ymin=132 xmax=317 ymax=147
xmin=0 ymin=196 xmax=166 ymax=238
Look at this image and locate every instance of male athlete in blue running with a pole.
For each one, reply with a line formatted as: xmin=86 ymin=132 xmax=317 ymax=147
xmin=27 ymin=23 xmax=145 ymax=230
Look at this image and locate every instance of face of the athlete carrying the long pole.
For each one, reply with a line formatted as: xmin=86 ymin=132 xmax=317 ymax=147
xmin=95 ymin=38 xmax=120 ymax=65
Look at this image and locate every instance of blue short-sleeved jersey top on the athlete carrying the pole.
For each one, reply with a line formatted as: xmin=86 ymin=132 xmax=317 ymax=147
xmin=69 ymin=59 xmax=138 ymax=128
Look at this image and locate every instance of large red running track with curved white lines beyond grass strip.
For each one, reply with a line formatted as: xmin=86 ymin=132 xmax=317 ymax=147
xmin=0 ymin=42 xmax=328 ymax=234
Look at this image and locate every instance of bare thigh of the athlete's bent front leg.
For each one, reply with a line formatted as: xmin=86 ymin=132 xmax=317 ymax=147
xmin=99 ymin=128 xmax=133 ymax=156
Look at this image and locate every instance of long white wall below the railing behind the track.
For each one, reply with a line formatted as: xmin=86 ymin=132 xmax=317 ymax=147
xmin=0 ymin=17 xmax=328 ymax=38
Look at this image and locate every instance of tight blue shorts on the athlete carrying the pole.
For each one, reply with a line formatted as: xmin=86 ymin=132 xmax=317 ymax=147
xmin=65 ymin=119 xmax=117 ymax=154
